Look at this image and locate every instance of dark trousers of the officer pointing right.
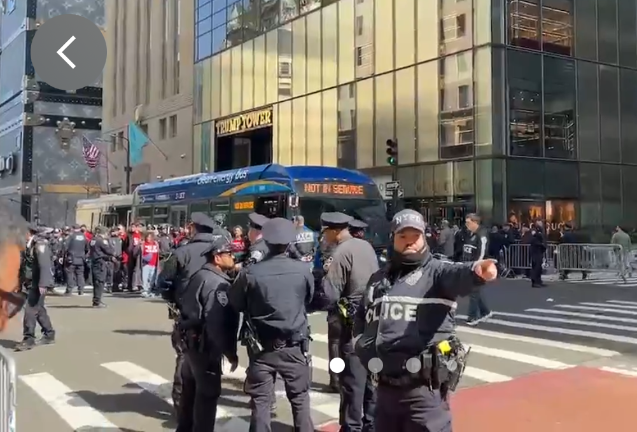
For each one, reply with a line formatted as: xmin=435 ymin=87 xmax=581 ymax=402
xmin=376 ymin=385 xmax=451 ymax=432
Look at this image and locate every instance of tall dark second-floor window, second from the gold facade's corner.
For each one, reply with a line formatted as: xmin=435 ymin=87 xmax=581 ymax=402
xmin=544 ymin=56 xmax=577 ymax=159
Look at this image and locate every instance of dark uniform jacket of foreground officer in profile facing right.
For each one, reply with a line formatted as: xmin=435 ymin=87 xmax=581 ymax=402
xmin=181 ymin=248 xmax=240 ymax=359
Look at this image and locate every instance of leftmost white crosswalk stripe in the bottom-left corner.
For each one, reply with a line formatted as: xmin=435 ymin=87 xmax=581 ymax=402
xmin=20 ymin=372 xmax=120 ymax=432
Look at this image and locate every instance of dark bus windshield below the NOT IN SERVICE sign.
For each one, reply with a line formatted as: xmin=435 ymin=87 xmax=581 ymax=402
xmin=300 ymin=197 xmax=390 ymax=248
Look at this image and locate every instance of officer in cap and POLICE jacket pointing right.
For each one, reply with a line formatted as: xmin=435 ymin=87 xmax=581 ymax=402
xmin=354 ymin=210 xmax=497 ymax=432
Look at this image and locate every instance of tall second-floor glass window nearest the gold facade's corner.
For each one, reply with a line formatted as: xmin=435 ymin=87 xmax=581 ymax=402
xmin=507 ymin=50 xmax=542 ymax=157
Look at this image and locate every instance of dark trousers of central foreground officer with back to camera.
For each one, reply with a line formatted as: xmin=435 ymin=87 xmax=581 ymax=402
xmin=244 ymin=346 xmax=314 ymax=432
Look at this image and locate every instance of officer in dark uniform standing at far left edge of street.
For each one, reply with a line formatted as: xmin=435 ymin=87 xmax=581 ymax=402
xmin=15 ymin=226 xmax=55 ymax=351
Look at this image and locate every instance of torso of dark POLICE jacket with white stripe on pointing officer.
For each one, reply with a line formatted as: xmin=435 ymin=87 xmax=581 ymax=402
xmin=356 ymin=264 xmax=458 ymax=373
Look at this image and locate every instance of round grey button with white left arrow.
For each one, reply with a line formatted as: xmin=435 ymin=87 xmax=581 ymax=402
xmin=31 ymin=15 xmax=106 ymax=90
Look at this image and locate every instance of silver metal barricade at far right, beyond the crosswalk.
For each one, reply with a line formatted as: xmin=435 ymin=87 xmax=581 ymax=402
xmin=557 ymin=244 xmax=630 ymax=282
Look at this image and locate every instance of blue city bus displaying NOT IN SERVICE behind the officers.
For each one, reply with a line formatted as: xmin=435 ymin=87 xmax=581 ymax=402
xmin=133 ymin=164 xmax=389 ymax=248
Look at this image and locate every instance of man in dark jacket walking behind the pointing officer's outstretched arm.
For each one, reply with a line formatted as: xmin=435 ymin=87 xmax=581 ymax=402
xmin=462 ymin=213 xmax=493 ymax=326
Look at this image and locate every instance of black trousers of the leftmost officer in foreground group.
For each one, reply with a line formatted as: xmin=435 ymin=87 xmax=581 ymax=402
xmin=176 ymin=350 xmax=221 ymax=432
